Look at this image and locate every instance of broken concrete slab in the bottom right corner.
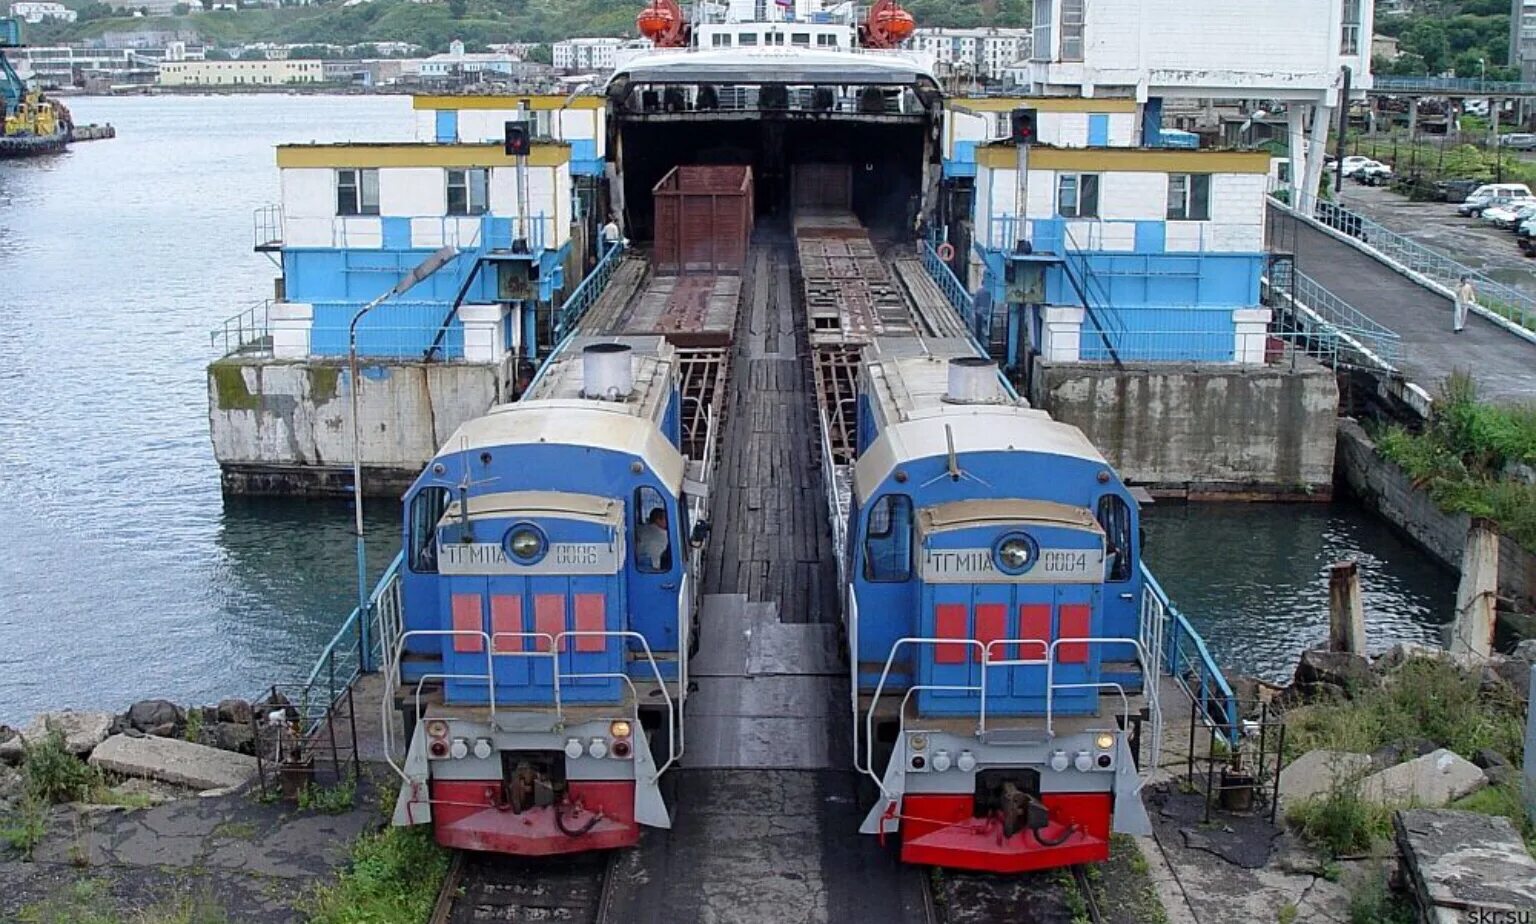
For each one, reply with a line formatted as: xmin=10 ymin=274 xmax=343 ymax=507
xmin=1392 ymin=809 xmax=1536 ymax=922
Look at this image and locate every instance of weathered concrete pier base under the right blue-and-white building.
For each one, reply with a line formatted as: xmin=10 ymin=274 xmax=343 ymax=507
xmin=1031 ymin=361 xmax=1338 ymax=500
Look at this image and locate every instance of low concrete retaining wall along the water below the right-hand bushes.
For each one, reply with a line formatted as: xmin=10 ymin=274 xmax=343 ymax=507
xmin=1338 ymin=421 xmax=1536 ymax=612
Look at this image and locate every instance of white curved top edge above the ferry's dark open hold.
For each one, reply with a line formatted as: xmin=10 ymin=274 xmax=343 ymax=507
xmin=608 ymin=46 xmax=935 ymax=86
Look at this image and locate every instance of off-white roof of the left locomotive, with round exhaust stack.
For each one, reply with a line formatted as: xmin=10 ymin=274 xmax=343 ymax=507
xmin=436 ymin=338 xmax=684 ymax=491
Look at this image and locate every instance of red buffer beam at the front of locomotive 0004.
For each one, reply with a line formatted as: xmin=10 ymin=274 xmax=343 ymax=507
xmin=902 ymin=792 xmax=1114 ymax=873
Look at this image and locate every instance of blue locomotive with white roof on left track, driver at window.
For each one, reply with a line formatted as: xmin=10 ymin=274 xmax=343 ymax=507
xmin=386 ymin=338 xmax=703 ymax=855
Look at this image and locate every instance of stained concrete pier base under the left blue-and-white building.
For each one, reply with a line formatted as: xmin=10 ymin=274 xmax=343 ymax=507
xmin=207 ymin=356 xmax=502 ymax=496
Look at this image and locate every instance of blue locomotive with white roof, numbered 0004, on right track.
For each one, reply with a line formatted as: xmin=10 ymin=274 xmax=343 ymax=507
xmin=829 ymin=336 xmax=1160 ymax=872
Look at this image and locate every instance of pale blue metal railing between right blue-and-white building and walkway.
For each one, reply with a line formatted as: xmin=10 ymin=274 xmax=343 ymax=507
xmin=1260 ymin=273 xmax=1402 ymax=371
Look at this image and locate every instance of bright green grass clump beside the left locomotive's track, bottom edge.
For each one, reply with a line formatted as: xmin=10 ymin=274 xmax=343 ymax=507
xmin=300 ymin=827 xmax=449 ymax=924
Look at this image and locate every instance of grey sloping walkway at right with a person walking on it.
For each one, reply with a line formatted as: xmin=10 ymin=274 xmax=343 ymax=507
xmin=1269 ymin=206 xmax=1536 ymax=402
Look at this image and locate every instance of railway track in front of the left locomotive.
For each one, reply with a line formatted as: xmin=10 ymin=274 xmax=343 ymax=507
xmin=430 ymin=850 xmax=622 ymax=924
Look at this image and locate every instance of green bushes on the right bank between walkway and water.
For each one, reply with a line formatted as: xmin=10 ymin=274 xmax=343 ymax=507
xmin=1375 ymin=373 xmax=1536 ymax=551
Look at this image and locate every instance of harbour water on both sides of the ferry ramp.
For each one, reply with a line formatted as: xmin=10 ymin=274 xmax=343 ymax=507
xmin=0 ymin=95 xmax=1455 ymax=724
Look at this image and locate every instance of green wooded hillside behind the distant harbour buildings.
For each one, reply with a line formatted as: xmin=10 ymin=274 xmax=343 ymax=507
xmin=28 ymin=0 xmax=1031 ymax=54
